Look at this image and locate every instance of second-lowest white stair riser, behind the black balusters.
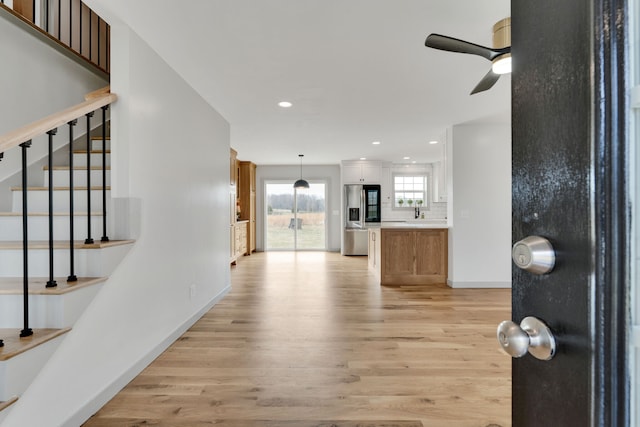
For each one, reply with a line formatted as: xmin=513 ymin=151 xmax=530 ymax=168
xmin=0 ymin=283 xmax=103 ymax=330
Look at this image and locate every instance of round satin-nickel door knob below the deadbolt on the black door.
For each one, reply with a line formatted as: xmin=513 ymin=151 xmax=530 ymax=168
xmin=497 ymin=317 xmax=556 ymax=360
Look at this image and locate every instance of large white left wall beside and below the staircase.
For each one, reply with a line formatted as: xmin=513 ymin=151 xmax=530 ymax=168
xmin=3 ymin=22 xmax=230 ymax=427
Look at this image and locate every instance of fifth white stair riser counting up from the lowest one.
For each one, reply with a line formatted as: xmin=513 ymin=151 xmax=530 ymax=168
xmin=12 ymin=190 xmax=111 ymax=212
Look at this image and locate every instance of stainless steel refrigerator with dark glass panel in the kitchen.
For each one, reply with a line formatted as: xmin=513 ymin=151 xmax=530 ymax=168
xmin=343 ymin=184 xmax=381 ymax=255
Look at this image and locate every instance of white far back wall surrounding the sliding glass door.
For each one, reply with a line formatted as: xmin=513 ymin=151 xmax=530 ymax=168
xmin=258 ymin=163 xmax=342 ymax=252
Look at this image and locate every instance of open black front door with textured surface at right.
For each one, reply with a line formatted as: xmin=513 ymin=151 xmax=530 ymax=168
xmin=511 ymin=0 xmax=629 ymax=427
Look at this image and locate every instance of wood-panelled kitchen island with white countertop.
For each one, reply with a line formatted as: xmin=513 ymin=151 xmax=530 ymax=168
xmin=368 ymin=222 xmax=448 ymax=285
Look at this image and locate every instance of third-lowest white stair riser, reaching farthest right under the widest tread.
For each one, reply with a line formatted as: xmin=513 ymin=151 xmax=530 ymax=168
xmin=0 ymin=244 xmax=130 ymax=277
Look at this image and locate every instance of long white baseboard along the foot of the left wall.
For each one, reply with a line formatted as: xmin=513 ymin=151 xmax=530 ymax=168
xmin=63 ymin=284 xmax=231 ymax=427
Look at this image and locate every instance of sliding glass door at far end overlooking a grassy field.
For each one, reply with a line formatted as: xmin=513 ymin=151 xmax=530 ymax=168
xmin=265 ymin=181 xmax=327 ymax=251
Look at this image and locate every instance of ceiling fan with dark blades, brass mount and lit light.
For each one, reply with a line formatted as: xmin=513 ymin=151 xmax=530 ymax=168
xmin=424 ymin=18 xmax=511 ymax=95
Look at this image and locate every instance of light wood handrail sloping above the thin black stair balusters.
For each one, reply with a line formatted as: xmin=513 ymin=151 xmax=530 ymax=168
xmin=0 ymin=92 xmax=118 ymax=153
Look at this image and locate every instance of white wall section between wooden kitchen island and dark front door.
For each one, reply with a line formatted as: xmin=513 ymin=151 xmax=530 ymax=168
xmin=448 ymin=125 xmax=511 ymax=288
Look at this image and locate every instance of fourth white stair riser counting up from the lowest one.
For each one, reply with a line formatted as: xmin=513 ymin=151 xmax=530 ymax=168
xmin=0 ymin=213 xmax=104 ymax=240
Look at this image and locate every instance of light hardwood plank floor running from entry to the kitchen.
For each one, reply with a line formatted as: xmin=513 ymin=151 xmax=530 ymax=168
xmin=85 ymin=252 xmax=511 ymax=427
